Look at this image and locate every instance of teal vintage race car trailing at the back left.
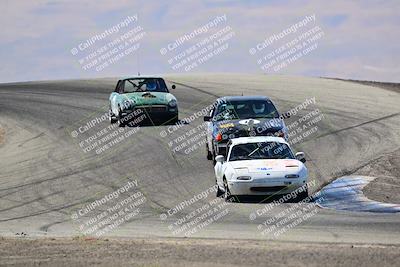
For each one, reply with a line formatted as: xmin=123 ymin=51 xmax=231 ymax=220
xmin=109 ymin=77 xmax=178 ymax=127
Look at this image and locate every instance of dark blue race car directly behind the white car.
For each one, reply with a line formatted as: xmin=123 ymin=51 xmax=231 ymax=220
xmin=204 ymin=96 xmax=288 ymax=162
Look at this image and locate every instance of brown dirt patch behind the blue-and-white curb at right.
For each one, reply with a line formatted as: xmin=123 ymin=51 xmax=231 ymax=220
xmin=356 ymin=149 xmax=400 ymax=204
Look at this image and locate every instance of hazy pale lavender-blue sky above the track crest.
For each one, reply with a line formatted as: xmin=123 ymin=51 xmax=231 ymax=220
xmin=0 ymin=0 xmax=400 ymax=82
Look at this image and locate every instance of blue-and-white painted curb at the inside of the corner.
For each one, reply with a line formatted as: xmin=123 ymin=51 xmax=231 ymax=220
xmin=317 ymin=176 xmax=400 ymax=213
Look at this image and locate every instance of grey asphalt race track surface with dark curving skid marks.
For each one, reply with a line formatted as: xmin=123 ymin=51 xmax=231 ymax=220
xmin=0 ymin=74 xmax=400 ymax=244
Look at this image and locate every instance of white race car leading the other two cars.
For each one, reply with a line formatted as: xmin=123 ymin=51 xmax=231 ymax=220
xmin=214 ymin=136 xmax=308 ymax=199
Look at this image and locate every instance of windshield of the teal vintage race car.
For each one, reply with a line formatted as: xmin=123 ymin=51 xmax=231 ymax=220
xmin=124 ymin=78 xmax=168 ymax=93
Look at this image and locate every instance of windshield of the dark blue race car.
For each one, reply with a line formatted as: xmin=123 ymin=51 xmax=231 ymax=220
xmin=214 ymin=100 xmax=279 ymax=121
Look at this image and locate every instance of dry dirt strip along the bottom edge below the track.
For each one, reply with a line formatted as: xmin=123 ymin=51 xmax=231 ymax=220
xmin=0 ymin=238 xmax=400 ymax=267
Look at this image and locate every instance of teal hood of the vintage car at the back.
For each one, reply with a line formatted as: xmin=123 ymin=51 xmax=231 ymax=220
xmin=124 ymin=92 xmax=176 ymax=106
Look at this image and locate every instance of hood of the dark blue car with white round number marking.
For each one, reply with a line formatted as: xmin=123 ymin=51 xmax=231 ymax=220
xmin=217 ymin=118 xmax=284 ymax=133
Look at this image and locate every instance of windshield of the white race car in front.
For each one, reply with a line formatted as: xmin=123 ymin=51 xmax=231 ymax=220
xmin=229 ymin=142 xmax=295 ymax=161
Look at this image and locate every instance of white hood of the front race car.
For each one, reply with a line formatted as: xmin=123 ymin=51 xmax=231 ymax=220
xmin=229 ymin=159 xmax=303 ymax=173
